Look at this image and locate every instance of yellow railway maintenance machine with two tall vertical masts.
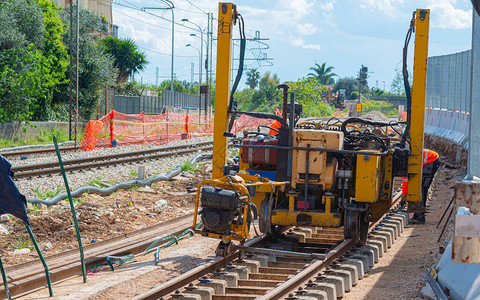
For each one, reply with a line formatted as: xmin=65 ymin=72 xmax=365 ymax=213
xmin=194 ymin=3 xmax=430 ymax=256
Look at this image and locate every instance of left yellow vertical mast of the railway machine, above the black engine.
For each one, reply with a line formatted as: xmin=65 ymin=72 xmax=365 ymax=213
xmin=212 ymin=3 xmax=235 ymax=179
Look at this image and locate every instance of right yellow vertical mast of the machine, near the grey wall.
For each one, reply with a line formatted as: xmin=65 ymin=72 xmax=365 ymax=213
xmin=407 ymin=9 xmax=430 ymax=206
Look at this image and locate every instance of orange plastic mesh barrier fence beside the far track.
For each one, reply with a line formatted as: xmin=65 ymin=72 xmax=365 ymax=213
xmin=81 ymin=110 xmax=273 ymax=151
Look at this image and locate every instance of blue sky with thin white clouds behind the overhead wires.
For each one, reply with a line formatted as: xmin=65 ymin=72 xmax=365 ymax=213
xmin=113 ymin=0 xmax=472 ymax=90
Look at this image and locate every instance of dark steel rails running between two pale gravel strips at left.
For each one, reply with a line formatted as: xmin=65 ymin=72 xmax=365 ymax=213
xmin=12 ymin=142 xmax=213 ymax=178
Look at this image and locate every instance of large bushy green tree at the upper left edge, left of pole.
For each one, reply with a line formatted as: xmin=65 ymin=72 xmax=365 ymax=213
xmin=0 ymin=0 xmax=68 ymax=122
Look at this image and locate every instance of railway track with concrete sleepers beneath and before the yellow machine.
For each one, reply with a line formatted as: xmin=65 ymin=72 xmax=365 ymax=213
xmin=133 ymin=194 xmax=408 ymax=300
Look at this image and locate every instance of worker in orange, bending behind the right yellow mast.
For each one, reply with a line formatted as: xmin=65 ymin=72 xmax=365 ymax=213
xmin=402 ymin=149 xmax=440 ymax=224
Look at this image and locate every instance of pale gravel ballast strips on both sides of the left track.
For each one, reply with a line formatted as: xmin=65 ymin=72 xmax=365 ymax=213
xmin=10 ymin=137 xmax=212 ymax=199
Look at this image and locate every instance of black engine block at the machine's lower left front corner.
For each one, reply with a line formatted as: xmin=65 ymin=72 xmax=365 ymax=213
xmin=200 ymin=186 xmax=242 ymax=234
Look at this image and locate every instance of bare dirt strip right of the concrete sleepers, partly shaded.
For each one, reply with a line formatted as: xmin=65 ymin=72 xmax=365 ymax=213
xmin=343 ymin=157 xmax=466 ymax=300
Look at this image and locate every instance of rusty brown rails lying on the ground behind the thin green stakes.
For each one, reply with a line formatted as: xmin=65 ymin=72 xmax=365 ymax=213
xmin=0 ymin=214 xmax=193 ymax=298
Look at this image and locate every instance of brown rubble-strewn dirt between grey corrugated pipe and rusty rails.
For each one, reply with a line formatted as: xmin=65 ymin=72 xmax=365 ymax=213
xmin=0 ymin=172 xmax=201 ymax=266
